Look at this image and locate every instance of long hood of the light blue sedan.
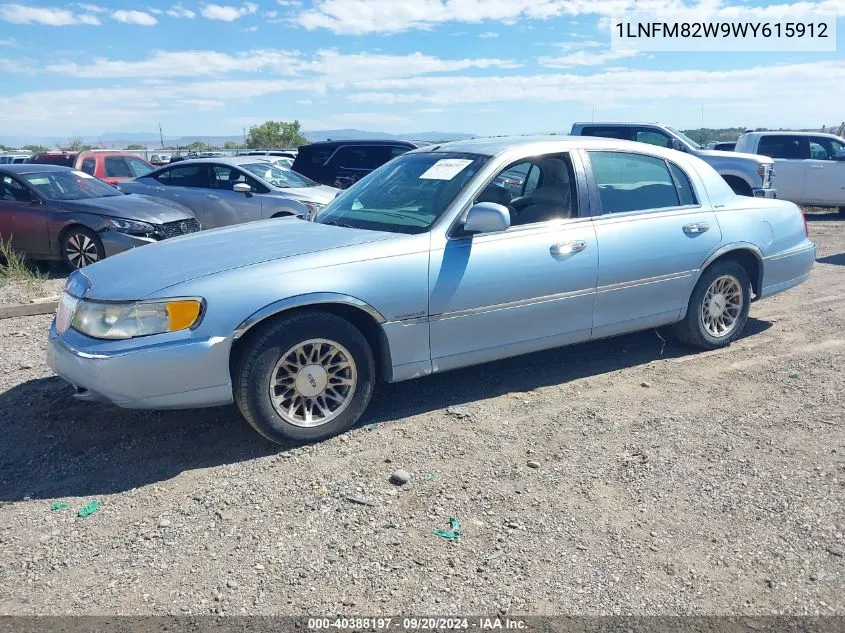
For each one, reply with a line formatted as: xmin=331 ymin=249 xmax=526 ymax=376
xmin=76 ymin=218 xmax=400 ymax=300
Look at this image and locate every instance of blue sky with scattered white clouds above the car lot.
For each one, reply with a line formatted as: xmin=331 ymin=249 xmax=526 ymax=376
xmin=0 ymin=0 xmax=845 ymax=137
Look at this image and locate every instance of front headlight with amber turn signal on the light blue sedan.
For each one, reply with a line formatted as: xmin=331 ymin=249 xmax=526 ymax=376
xmin=71 ymin=299 xmax=203 ymax=339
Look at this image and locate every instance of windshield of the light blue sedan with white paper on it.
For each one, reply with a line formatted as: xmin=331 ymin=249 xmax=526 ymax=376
xmin=314 ymin=152 xmax=487 ymax=233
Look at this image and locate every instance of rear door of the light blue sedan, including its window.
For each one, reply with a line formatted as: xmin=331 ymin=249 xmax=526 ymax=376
xmin=585 ymin=150 xmax=721 ymax=338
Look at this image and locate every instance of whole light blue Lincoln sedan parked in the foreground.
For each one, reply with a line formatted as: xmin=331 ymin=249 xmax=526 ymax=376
xmin=49 ymin=137 xmax=816 ymax=443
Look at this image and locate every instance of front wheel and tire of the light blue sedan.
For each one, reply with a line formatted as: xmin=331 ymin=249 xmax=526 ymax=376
xmin=233 ymin=310 xmax=376 ymax=444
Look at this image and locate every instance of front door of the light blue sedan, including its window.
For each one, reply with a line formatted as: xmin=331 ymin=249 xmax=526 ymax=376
xmin=429 ymin=154 xmax=598 ymax=371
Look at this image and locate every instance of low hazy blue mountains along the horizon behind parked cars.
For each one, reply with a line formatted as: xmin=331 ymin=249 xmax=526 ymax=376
xmin=0 ymin=129 xmax=476 ymax=149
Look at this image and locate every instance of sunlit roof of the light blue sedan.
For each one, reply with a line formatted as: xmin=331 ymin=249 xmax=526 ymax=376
xmin=410 ymin=135 xmax=677 ymax=156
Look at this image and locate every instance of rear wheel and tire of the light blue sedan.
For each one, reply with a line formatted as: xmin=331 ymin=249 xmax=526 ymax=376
xmin=673 ymin=259 xmax=751 ymax=349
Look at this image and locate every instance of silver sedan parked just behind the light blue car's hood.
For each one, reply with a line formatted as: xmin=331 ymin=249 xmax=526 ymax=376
xmin=120 ymin=156 xmax=339 ymax=229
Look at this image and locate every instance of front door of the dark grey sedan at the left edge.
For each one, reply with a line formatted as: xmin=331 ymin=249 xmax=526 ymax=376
xmin=0 ymin=176 xmax=50 ymax=258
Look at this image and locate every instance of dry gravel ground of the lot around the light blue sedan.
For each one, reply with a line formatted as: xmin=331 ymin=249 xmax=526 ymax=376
xmin=0 ymin=215 xmax=845 ymax=615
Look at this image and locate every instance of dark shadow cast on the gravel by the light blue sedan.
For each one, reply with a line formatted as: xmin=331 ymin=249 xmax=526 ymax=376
xmin=0 ymin=319 xmax=771 ymax=503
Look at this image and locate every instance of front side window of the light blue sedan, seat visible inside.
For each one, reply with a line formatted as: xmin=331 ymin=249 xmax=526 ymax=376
xmin=476 ymin=154 xmax=578 ymax=226
